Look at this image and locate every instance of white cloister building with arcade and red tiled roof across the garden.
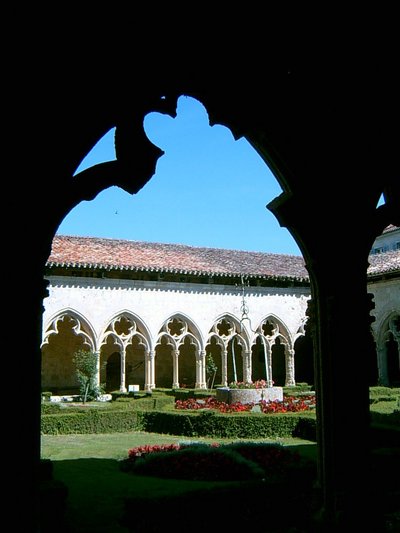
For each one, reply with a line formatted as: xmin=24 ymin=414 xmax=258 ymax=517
xmin=42 ymin=227 xmax=400 ymax=394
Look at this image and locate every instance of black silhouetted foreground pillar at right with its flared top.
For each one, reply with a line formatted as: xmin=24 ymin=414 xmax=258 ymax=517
xmin=268 ymin=187 xmax=380 ymax=531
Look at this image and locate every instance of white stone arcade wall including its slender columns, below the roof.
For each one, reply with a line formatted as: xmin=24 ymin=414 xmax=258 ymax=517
xmin=43 ymin=276 xmax=400 ymax=389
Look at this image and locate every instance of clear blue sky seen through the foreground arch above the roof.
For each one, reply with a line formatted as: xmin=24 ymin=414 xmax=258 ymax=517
xmin=57 ymin=96 xmax=300 ymax=255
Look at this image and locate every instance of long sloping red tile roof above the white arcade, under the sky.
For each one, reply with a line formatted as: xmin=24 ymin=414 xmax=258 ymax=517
xmin=47 ymin=235 xmax=308 ymax=280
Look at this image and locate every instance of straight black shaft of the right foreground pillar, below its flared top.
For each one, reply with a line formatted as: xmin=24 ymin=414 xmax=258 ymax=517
xmin=314 ymin=282 xmax=374 ymax=531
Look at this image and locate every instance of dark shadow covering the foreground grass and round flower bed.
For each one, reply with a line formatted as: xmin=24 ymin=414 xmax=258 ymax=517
xmin=42 ymin=444 xmax=400 ymax=533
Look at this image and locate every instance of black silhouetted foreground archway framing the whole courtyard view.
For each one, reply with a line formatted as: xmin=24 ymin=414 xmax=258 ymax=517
xmin=13 ymin=36 xmax=400 ymax=531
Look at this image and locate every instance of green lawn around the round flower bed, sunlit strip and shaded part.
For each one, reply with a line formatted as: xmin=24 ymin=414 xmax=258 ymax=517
xmin=41 ymin=432 xmax=316 ymax=533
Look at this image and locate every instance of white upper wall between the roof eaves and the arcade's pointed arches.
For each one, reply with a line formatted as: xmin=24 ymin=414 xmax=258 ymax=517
xmin=43 ymin=276 xmax=310 ymax=349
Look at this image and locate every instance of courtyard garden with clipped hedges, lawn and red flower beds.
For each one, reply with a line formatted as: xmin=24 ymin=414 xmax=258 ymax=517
xmin=42 ymin=388 xmax=400 ymax=533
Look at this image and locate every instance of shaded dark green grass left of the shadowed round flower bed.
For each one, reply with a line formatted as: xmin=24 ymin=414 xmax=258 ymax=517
xmin=47 ymin=459 xmax=284 ymax=533
